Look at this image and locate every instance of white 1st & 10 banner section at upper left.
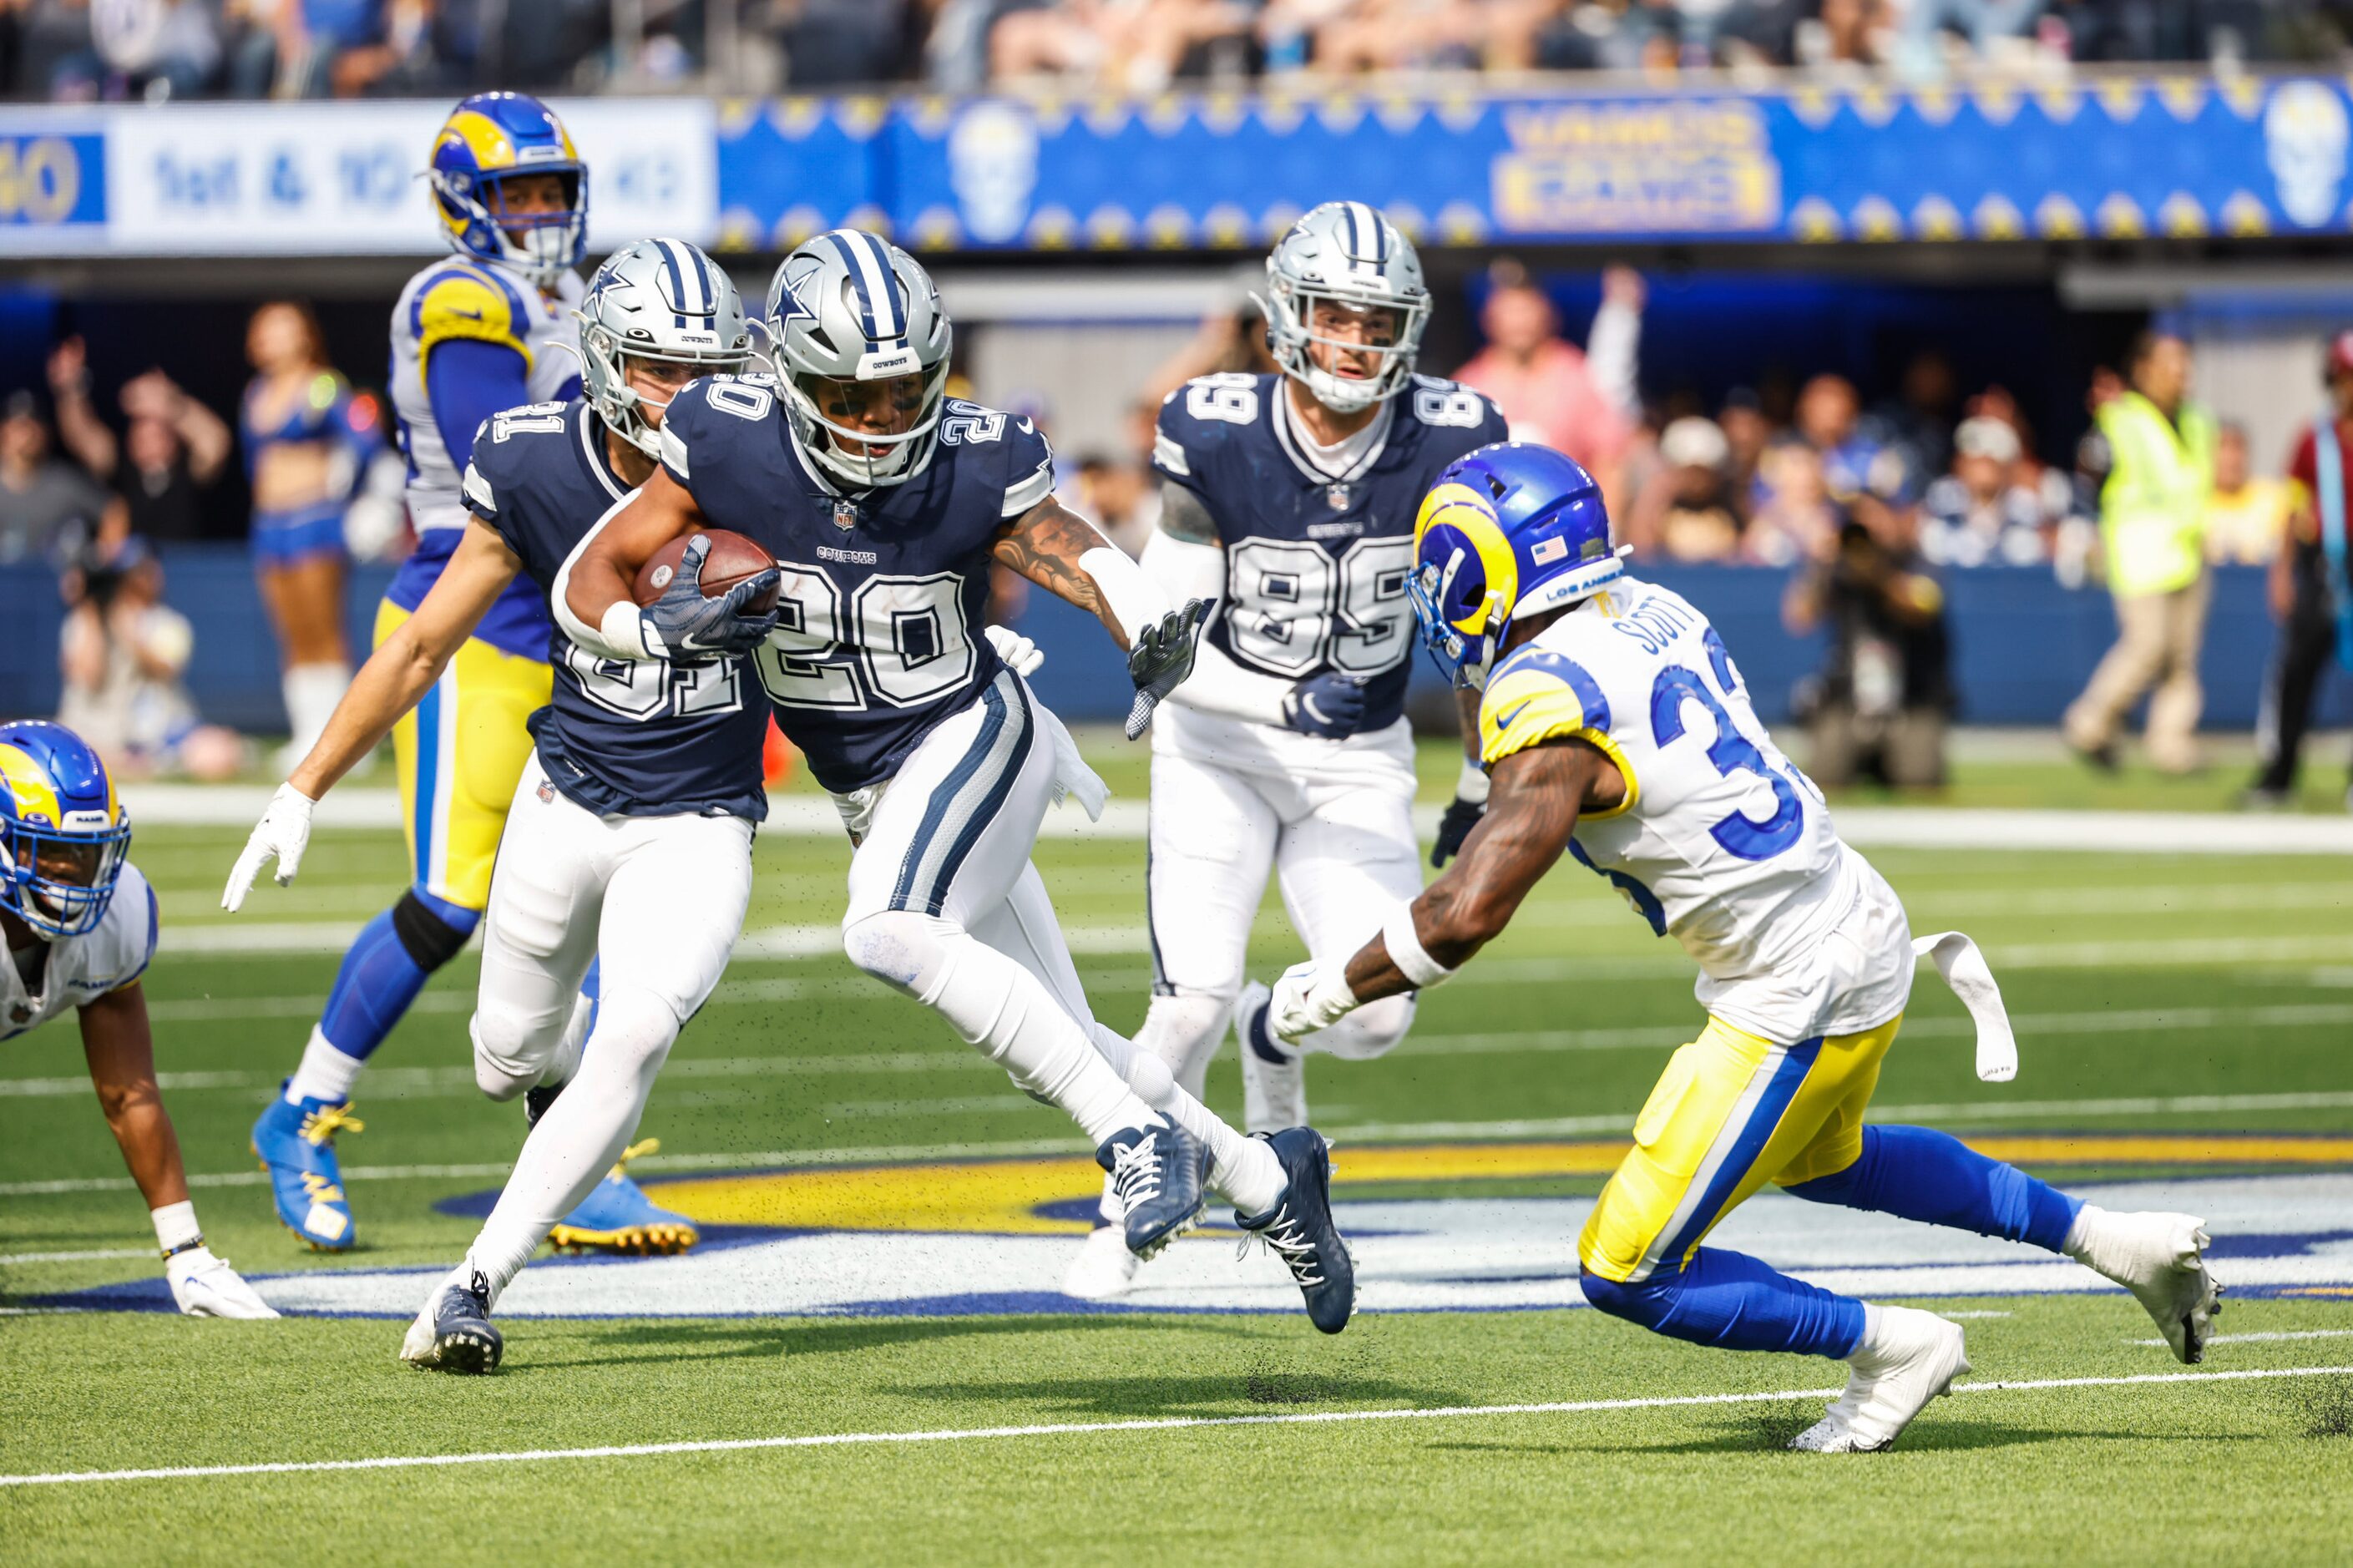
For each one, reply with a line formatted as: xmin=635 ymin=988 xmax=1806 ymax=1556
xmin=0 ymin=99 xmax=717 ymax=256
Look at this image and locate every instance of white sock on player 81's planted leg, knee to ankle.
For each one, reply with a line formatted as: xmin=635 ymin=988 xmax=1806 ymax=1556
xmin=452 ymin=989 xmax=678 ymax=1304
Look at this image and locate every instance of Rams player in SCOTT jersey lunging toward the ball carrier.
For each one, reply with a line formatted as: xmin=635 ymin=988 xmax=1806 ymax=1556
xmin=1271 ymin=445 xmax=2219 ymax=1453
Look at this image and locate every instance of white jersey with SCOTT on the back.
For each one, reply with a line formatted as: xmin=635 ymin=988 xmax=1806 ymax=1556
xmin=1480 ymin=577 xmax=1913 ymax=1043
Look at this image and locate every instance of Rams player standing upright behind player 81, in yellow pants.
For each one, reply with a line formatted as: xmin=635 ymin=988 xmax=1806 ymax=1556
xmin=239 ymin=92 xmax=630 ymax=1252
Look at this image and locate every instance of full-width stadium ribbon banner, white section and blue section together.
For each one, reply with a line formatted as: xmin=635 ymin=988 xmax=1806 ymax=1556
xmin=0 ymin=75 xmax=2353 ymax=256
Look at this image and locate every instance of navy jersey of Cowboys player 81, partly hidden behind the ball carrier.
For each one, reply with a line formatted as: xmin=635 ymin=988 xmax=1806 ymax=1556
xmin=463 ymin=398 xmax=767 ymax=822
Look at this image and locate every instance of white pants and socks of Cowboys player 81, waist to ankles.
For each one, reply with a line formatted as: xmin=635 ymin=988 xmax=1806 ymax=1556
xmin=466 ymin=753 xmax=753 ymax=1300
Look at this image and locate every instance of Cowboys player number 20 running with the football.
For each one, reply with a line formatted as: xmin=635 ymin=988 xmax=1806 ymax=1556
xmin=555 ymin=229 xmax=1355 ymax=1333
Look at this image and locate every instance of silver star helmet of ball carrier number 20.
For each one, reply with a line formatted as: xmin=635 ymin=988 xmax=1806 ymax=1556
xmin=767 ymin=229 xmax=953 ymax=485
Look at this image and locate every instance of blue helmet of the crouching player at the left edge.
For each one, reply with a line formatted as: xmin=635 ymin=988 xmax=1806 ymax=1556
xmin=0 ymin=723 xmax=132 ymax=942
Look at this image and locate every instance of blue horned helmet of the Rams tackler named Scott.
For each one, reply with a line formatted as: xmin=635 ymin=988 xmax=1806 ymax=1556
xmin=1404 ymin=440 xmax=1626 ymax=687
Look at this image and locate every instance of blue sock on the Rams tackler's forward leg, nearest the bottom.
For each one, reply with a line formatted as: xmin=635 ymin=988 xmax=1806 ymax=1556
xmin=1579 ymin=1248 xmax=1864 ymax=1358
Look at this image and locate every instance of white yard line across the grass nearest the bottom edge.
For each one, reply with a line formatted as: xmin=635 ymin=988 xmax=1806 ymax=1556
xmin=0 ymin=1365 xmax=2353 ymax=1485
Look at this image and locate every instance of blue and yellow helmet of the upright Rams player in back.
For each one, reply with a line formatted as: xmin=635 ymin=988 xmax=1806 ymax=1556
xmin=426 ymin=92 xmax=589 ymax=287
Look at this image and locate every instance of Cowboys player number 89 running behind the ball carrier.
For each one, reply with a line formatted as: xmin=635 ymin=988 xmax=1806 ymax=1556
xmin=1066 ymin=203 xmax=1504 ymax=1297
